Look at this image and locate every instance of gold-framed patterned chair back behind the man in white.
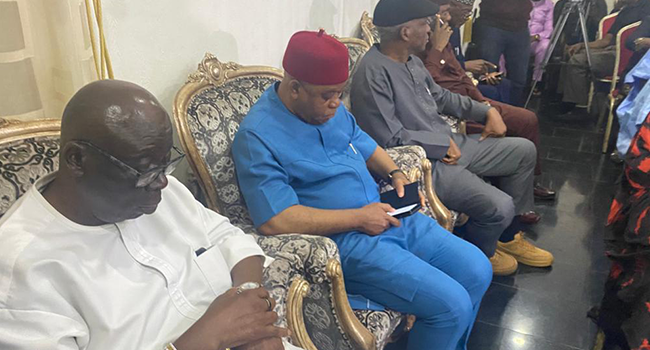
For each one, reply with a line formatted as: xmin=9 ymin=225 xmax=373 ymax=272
xmin=0 ymin=119 xmax=61 ymax=216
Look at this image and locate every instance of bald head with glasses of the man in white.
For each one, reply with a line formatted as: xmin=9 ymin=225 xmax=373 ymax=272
xmin=48 ymin=80 xmax=173 ymax=224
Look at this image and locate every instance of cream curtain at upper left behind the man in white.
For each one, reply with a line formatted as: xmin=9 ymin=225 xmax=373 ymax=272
xmin=0 ymin=0 xmax=98 ymax=120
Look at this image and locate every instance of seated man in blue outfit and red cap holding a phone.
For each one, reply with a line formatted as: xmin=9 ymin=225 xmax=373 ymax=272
xmin=233 ymin=30 xmax=491 ymax=350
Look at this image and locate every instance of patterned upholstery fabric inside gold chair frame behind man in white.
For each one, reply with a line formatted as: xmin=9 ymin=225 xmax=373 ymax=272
xmin=0 ymin=136 xmax=59 ymax=216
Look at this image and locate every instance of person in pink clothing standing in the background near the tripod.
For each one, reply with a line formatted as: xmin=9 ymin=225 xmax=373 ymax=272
xmin=528 ymin=0 xmax=553 ymax=95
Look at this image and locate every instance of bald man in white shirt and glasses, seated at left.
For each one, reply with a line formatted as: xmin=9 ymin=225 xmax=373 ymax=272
xmin=0 ymin=80 xmax=295 ymax=350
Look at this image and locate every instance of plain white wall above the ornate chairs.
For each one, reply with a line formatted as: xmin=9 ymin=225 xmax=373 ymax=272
xmin=103 ymin=0 xmax=378 ymax=113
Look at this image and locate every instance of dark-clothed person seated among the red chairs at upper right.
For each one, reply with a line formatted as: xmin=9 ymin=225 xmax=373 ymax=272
xmin=558 ymin=0 xmax=650 ymax=121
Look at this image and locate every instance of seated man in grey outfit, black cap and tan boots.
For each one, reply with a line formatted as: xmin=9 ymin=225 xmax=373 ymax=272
xmin=350 ymin=0 xmax=553 ymax=274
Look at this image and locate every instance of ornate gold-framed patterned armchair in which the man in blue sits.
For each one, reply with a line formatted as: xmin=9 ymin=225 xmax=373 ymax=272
xmin=174 ymin=54 xmax=448 ymax=350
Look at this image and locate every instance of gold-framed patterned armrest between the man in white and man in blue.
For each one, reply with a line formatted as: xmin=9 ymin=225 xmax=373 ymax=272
xmin=239 ymin=225 xmax=375 ymax=350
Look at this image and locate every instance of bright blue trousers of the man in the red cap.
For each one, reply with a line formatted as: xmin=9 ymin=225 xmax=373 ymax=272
xmin=332 ymin=213 xmax=492 ymax=350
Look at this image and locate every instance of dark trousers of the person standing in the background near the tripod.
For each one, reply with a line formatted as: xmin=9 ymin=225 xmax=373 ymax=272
xmin=472 ymin=20 xmax=530 ymax=106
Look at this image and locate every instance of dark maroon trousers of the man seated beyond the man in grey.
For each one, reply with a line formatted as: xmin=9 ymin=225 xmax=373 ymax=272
xmin=467 ymin=99 xmax=542 ymax=175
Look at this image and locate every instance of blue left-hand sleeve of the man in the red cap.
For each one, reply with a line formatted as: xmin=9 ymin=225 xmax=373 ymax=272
xmin=232 ymin=130 xmax=300 ymax=227
